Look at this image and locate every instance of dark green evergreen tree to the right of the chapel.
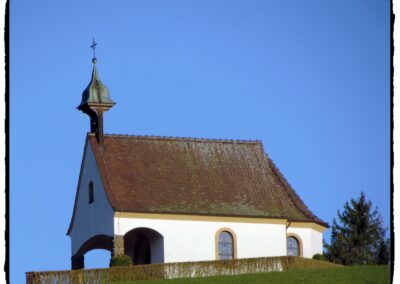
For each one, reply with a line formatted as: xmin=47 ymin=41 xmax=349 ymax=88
xmin=325 ymin=192 xmax=389 ymax=265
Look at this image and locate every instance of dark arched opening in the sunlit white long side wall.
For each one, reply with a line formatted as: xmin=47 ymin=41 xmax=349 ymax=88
xmin=124 ymin=228 xmax=164 ymax=264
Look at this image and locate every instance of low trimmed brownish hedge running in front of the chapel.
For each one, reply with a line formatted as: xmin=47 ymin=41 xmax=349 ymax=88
xmin=26 ymin=256 xmax=341 ymax=284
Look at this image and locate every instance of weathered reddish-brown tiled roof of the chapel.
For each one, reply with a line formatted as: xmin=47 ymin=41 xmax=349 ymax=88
xmin=88 ymin=134 xmax=328 ymax=227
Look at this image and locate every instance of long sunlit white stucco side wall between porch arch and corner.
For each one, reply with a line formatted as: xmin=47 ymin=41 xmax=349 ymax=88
xmin=114 ymin=217 xmax=286 ymax=262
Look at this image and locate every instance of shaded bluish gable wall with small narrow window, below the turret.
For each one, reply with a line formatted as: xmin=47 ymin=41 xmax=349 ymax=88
xmin=70 ymin=143 xmax=114 ymax=255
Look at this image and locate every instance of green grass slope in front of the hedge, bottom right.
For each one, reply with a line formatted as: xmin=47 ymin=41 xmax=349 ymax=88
xmin=118 ymin=266 xmax=390 ymax=284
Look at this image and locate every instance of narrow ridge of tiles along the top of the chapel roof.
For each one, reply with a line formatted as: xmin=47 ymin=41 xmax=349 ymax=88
xmin=97 ymin=133 xmax=262 ymax=144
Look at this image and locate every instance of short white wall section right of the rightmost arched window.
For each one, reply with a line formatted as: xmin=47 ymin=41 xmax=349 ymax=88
xmin=287 ymin=227 xmax=322 ymax=258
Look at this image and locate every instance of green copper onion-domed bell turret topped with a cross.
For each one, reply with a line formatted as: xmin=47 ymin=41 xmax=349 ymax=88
xmin=77 ymin=39 xmax=115 ymax=147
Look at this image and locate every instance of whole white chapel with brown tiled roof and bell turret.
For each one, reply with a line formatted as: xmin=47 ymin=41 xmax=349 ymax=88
xmin=67 ymin=55 xmax=328 ymax=269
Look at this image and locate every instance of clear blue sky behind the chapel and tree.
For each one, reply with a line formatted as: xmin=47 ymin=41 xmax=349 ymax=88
xmin=9 ymin=0 xmax=391 ymax=283
